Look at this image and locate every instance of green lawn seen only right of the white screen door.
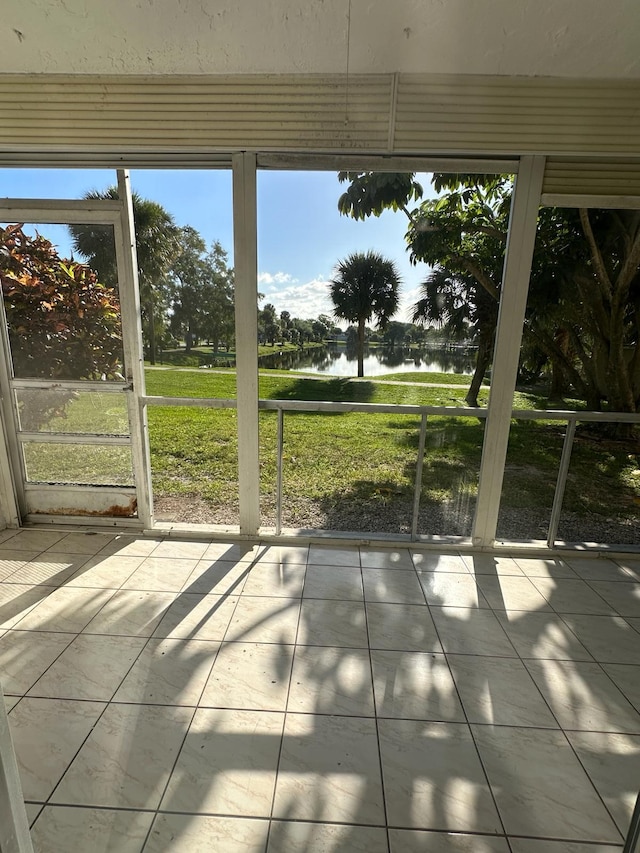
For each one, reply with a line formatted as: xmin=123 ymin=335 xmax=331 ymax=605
xmin=142 ymin=371 xmax=640 ymax=516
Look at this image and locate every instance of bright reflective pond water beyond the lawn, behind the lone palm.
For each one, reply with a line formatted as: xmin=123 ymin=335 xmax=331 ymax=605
xmin=260 ymin=344 xmax=475 ymax=376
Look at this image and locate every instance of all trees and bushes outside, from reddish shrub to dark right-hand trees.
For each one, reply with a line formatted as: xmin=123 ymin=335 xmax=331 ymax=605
xmin=0 ymin=172 xmax=640 ymax=420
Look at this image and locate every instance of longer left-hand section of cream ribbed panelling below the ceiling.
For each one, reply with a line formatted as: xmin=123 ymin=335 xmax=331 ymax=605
xmin=0 ymin=75 xmax=392 ymax=159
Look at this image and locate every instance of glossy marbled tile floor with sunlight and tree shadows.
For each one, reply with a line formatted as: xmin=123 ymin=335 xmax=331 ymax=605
xmin=0 ymin=530 xmax=640 ymax=853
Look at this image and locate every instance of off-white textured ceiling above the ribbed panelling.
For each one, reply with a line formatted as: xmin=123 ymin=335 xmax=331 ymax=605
xmin=0 ymin=0 xmax=640 ymax=78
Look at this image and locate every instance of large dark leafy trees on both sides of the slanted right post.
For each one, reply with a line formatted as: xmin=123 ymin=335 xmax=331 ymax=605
xmin=339 ymin=173 xmax=640 ymax=411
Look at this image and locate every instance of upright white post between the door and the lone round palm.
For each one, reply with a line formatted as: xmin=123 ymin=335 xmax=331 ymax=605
xmin=233 ymin=153 xmax=260 ymax=536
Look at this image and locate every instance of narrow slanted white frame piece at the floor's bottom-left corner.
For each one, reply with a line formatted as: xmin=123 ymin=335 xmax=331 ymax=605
xmin=0 ymin=685 xmax=33 ymax=853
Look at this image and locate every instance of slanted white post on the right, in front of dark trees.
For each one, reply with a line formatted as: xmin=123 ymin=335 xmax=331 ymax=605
xmin=471 ymin=157 xmax=545 ymax=546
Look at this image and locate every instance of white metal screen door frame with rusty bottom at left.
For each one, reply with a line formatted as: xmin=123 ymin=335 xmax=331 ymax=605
xmin=0 ymin=170 xmax=153 ymax=528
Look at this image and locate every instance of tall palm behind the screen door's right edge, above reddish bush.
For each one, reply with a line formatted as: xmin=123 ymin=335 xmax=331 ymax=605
xmin=69 ymin=187 xmax=182 ymax=364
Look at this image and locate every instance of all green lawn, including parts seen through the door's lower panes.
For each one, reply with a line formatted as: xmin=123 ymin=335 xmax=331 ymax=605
xmin=22 ymin=369 xmax=640 ymax=533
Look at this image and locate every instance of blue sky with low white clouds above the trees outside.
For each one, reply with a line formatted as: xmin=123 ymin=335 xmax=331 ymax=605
xmin=0 ymin=169 xmax=430 ymax=319
